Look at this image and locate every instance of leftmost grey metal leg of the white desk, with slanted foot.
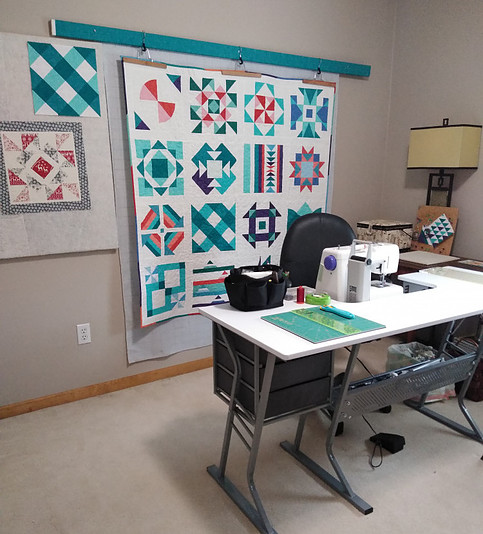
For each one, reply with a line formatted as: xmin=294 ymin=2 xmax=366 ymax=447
xmin=207 ymin=325 xmax=277 ymax=534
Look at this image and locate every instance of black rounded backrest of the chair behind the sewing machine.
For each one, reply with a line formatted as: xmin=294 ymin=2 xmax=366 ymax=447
xmin=280 ymin=213 xmax=356 ymax=287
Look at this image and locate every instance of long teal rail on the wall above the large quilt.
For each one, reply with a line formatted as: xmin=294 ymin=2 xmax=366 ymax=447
xmin=50 ymin=19 xmax=371 ymax=78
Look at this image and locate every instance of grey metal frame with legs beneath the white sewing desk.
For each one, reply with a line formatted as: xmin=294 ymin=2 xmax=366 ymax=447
xmin=201 ymin=274 xmax=483 ymax=534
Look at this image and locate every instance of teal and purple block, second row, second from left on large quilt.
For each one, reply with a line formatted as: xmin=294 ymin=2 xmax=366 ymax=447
xmin=192 ymin=143 xmax=236 ymax=195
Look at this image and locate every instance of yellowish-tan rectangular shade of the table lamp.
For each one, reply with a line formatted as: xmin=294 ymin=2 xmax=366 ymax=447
xmin=408 ymin=124 xmax=481 ymax=169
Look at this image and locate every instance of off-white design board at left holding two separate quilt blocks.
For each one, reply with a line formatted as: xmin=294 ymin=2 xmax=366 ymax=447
xmin=0 ymin=33 xmax=118 ymax=259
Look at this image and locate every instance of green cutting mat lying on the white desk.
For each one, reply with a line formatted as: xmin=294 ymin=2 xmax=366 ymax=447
xmin=262 ymin=306 xmax=384 ymax=343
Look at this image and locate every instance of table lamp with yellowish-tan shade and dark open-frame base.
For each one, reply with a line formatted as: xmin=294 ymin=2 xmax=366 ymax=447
xmin=408 ymin=119 xmax=481 ymax=206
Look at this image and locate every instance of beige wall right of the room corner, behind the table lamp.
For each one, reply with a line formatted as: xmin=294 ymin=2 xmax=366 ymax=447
xmin=380 ymin=0 xmax=483 ymax=260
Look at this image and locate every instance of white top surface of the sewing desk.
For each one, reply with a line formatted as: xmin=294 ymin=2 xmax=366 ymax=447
xmin=200 ymin=272 xmax=483 ymax=360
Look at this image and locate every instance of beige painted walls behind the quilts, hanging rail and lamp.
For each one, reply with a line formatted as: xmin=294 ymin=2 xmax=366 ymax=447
xmin=4 ymin=0 xmax=483 ymax=405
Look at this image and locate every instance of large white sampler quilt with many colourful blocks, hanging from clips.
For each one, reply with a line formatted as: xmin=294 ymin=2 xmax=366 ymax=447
xmin=123 ymin=58 xmax=335 ymax=326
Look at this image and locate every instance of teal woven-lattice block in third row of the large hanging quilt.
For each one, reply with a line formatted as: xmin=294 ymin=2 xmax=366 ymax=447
xmin=191 ymin=203 xmax=236 ymax=253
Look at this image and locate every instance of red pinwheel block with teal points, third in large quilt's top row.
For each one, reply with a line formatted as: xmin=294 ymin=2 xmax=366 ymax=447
xmin=245 ymin=82 xmax=284 ymax=136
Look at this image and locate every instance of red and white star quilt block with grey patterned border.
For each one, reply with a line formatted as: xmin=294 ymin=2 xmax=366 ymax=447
xmin=0 ymin=121 xmax=90 ymax=214
